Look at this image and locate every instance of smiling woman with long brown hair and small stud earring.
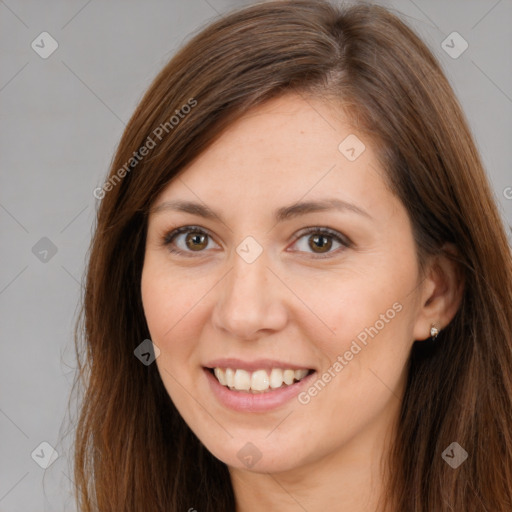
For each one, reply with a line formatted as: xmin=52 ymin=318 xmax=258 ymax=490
xmin=75 ymin=1 xmax=512 ymax=512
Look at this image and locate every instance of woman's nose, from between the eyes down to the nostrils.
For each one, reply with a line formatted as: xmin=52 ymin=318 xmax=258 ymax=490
xmin=212 ymin=249 xmax=288 ymax=340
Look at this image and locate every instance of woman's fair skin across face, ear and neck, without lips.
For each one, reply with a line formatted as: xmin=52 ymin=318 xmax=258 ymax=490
xmin=141 ymin=94 xmax=460 ymax=512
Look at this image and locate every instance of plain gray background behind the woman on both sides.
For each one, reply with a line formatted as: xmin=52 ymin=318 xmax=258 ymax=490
xmin=0 ymin=0 xmax=512 ymax=512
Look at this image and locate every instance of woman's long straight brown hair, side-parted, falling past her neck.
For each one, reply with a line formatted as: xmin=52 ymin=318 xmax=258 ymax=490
xmin=74 ymin=0 xmax=512 ymax=512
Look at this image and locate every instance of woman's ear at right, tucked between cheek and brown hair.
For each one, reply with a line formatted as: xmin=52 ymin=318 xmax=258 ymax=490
xmin=414 ymin=244 xmax=464 ymax=340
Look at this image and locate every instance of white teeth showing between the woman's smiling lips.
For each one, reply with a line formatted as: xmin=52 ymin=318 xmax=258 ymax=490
xmin=206 ymin=367 xmax=314 ymax=393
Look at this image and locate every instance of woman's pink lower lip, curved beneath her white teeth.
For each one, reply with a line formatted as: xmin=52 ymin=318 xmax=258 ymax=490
xmin=204 ymin=368 xmax=316 ymax=412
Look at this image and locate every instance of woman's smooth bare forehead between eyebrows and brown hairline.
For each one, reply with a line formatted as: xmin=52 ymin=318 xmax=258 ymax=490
xmin=151 ymin=94 xmax=390 ymax=220
